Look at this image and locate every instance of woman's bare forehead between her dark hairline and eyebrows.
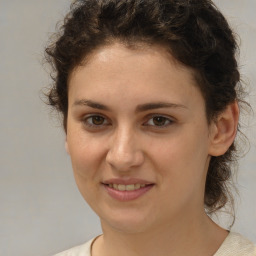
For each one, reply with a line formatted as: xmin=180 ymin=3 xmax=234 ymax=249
xmin=69 ymin=44 xmax=203 ymax=109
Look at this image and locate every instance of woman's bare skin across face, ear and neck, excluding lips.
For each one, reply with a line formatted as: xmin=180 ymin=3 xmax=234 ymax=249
xmin=66 ymin=43 xmax=238 ymax=256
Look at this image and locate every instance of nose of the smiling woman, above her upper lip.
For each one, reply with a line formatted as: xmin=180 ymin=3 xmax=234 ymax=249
xmin=106 ymin=128 xmax=144 ymax=172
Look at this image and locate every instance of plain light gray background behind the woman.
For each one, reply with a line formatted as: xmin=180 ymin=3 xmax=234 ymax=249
xmin=0 ymin=0 xmax=256 ymax=256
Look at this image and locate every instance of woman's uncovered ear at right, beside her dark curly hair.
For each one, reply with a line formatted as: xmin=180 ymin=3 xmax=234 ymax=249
xmin=209 ymin=101 xmax=239 ymax=156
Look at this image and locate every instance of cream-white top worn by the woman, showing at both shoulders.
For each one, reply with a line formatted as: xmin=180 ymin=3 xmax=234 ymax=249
xmin=54 ymin=232 xmax=256 ymax=256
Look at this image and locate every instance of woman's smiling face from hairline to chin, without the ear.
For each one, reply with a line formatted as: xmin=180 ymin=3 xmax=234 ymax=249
xmin=66 ymin=44 xmax=214 ymax=232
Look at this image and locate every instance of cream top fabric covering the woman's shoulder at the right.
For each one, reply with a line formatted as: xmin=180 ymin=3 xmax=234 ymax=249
xmin=214 ymin=232 xmax=256 ymax=256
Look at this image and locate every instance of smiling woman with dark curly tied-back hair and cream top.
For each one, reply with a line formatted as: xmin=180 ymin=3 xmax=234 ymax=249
xmin=46 ymin=0 xmax=256 ymax=256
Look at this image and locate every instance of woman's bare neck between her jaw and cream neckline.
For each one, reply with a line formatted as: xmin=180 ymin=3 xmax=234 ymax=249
xmin=92 ymin=212 xmax=228 ymax=256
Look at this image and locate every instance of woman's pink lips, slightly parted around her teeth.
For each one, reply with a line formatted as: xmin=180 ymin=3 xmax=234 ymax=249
xmin=102 ymin=178 xmax=155 ymax=202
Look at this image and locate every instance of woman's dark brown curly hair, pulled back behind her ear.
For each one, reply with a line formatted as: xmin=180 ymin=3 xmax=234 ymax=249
xmin=45 ymin=0 xmax=248 ymax=216
